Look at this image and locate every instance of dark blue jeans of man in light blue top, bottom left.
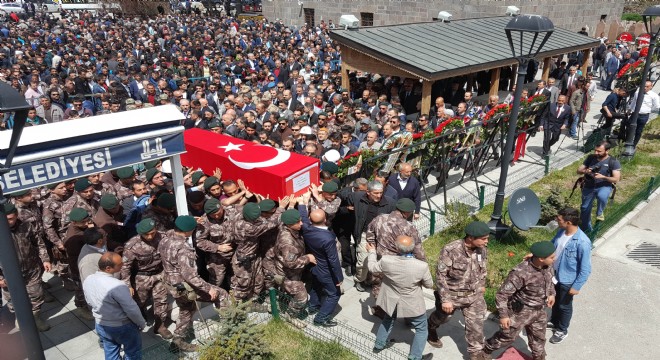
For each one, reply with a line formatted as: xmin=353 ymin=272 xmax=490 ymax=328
xmin=96 ymin=323 xmax=142 ymax=360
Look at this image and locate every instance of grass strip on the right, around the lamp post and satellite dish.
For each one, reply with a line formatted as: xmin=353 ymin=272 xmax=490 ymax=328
xmin=424 ymin=118 xmax=660 ymax=311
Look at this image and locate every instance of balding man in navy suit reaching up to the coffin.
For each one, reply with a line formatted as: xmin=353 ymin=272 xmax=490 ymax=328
xmin=298 ymin=192 xmax=344 ymax=327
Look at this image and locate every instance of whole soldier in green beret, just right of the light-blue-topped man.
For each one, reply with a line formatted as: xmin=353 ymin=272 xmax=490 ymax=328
xmin=121 ymin=218 xmax=172 ymax=339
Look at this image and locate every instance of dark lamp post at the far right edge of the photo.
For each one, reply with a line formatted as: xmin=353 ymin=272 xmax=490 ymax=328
xmin=622 ymin=5 xmax=660 ymax=159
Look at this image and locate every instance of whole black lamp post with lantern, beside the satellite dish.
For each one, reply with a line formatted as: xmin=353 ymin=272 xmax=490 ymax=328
xmin=488 ymin=15 xmax=555 ymax=238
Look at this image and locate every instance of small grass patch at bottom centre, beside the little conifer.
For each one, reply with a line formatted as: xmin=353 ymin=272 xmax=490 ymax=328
xmin=263 ymin=320 xmax=359 ymax=360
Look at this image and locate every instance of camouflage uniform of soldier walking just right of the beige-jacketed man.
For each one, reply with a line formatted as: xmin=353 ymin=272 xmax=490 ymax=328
xmin=429 ymin=239 xmax=487 ymax=356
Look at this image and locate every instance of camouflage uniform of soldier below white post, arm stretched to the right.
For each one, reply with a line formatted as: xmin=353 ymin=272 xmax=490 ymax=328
xmin=158 ymin=230 xmax=228 ymax=338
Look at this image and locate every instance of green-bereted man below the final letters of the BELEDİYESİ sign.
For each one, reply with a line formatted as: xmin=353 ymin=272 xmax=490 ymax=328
xmin=92 ymin=194 xmax=128 ymax=255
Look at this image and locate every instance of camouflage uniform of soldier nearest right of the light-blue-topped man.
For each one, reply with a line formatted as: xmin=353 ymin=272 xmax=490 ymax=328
xmin=121 ymin=233 xmax=168 ymax=322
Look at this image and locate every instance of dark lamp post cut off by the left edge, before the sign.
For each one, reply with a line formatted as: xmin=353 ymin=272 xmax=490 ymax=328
xmin=0 ymin=82 xmax=44 ymax=360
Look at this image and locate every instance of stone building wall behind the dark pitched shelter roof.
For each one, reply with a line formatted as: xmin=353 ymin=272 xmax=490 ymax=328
xmin=263 ymin=0 xmax=624 ymax=35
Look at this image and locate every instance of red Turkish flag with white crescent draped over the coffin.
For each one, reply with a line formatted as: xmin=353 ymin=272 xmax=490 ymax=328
xmin=181 ymin=129 xmax=319 ymax=200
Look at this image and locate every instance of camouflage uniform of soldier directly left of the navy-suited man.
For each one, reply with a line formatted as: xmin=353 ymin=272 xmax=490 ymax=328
xmin=274 ymin=225 xmax=309 ymax=311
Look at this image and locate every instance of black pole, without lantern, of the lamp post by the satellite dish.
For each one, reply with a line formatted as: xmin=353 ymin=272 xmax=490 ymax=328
xmin=488 ymin=58 xmax=529 ymax=229
